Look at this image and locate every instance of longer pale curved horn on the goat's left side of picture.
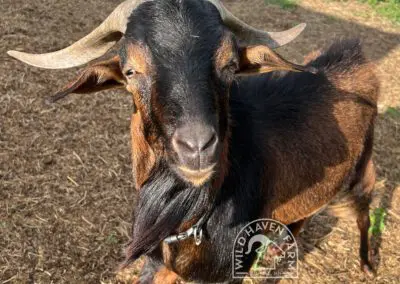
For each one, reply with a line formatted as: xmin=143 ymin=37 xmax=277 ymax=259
xmin=7 ymin=0 xmax=146 ymax=69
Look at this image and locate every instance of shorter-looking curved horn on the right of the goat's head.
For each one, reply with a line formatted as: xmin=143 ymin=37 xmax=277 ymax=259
xmin=207 ymin=0 xmax=306 ymax=49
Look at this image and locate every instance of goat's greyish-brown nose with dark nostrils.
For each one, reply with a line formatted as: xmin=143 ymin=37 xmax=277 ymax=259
xmin=172 ymin=123 xmax=218 ymax=170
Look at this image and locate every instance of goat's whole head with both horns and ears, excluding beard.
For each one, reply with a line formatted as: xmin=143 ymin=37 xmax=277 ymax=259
xmin=9 ymin=0 xmax=305 ymax=187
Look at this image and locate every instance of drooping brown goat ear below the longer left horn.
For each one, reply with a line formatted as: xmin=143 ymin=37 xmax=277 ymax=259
xmin=47 ymin=56 xmax=125 ymax=103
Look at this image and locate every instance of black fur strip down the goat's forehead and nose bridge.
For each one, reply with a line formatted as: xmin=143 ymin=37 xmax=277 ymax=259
xmin=126 ymin=0 xmax=224 ymax=137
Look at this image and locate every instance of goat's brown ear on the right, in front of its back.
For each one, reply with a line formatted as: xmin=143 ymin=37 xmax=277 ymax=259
xmin=237 ymin=45 xmax=316 ymax=75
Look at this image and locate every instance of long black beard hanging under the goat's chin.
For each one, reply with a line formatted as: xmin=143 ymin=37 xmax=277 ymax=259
xmin=123 ymin=164 xmax=212 ymax=267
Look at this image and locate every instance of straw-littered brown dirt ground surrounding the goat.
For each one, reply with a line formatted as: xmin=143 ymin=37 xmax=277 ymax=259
xmin=0 ymin=0 xmax=400 ymax=284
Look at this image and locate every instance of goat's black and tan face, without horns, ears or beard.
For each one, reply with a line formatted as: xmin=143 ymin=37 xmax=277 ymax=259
xmin=120 ymin=1 xmax=239 ymax=186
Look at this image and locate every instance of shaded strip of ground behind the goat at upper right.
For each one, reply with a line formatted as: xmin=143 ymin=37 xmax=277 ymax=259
xmin=223 ymin=0 xmax=400 ymax=60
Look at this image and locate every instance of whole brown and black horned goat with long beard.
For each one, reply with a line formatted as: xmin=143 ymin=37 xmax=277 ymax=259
xmin=9 ymin=0 xmax=378 ymax=283
